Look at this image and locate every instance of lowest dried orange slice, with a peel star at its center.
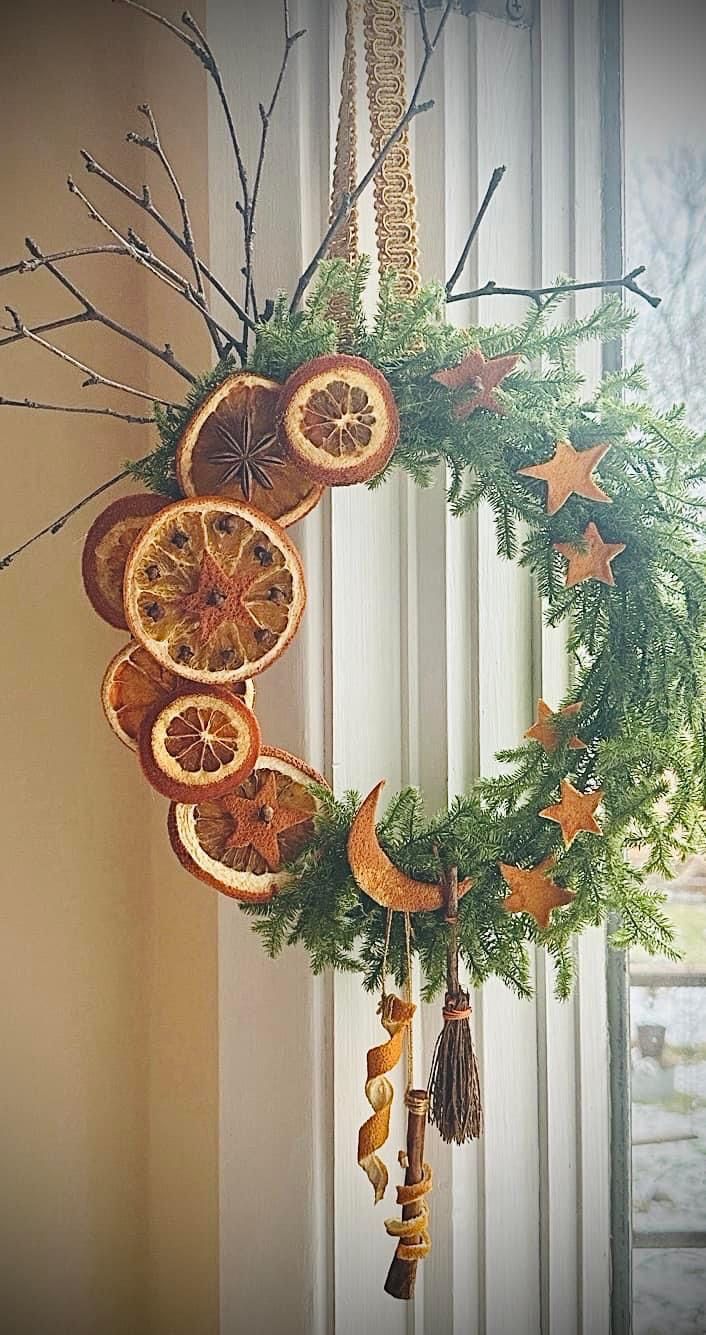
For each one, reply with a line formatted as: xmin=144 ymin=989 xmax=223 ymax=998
xmin=168 ymin=746 xmax=324 ymax=902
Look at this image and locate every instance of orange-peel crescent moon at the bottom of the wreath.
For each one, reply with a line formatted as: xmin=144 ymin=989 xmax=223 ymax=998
xmin=347 ymin=778 xmax=472 ymax=913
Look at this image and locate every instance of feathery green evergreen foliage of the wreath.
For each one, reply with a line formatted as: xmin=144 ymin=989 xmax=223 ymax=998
xmin=124 ymin=259 xmax=706 ymax=996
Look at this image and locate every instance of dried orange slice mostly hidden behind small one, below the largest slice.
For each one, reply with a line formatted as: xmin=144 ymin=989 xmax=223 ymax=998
xmin=100 ymin=639 xmax=255 ymax=750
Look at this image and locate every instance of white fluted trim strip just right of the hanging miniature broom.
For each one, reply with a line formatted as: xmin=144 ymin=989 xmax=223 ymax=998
xmin=474 ymin=17 xmax=541 ymax=1335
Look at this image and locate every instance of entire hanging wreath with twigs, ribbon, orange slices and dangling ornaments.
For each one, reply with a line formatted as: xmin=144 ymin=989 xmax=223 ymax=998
xmin=0 ymin=0 xmax=706 ymax=1298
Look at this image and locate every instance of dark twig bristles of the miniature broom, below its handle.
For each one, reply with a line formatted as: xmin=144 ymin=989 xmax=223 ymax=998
xmin=428 ymin=992 xmax=483 ymax=1145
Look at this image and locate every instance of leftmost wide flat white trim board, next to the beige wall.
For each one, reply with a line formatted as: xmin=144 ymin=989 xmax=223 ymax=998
xmin=210 ymin=0 xmax=332 ymax=1335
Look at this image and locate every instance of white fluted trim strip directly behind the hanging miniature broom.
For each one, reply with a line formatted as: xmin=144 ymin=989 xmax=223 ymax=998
xmin=410 ymin=15 xmax=480 ymax=1335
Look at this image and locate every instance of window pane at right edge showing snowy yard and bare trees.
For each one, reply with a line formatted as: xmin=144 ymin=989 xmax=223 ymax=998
xmin=623 ymin=0 xmax=706 ymax=1335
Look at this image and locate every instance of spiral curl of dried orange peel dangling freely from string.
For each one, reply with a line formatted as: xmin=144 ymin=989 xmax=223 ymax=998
xmin=358 ymin=995 xmax=416 ymax=1204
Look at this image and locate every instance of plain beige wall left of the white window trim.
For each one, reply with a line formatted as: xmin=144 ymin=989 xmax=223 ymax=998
xmin=0 ymin=0 xmax=218 ymax=1335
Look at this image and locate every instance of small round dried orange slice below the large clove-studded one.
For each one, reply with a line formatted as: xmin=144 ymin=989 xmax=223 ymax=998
xmin=137 ymin=686 xmax=260 ymax=802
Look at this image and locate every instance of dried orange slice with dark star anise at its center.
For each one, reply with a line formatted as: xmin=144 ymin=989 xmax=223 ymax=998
xmin=176 ymin=371 xmax=323 ymax=529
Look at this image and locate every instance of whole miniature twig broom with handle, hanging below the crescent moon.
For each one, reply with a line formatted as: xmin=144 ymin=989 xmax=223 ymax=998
xmin=428 ymin=866 xmax=483 ymax=1145
